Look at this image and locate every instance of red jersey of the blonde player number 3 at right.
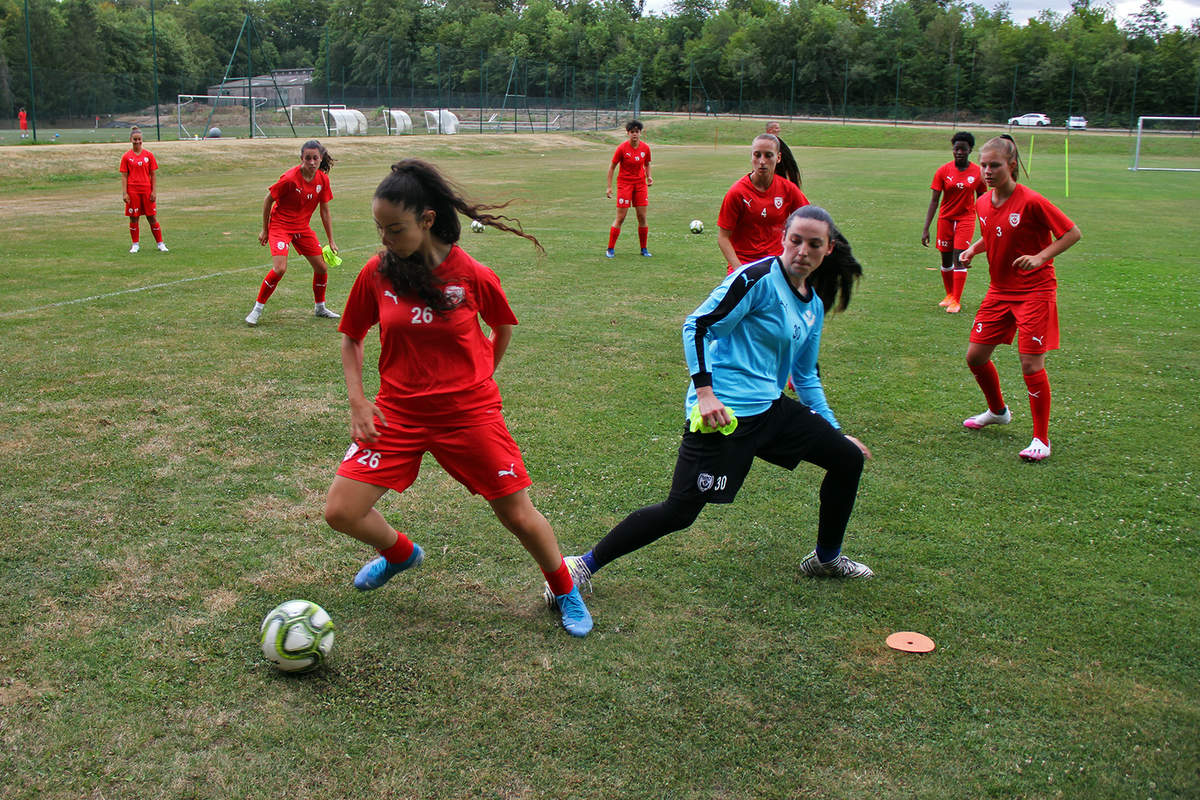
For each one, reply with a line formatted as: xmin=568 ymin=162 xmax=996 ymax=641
xmin=976 ymin=184 xmax=1075 ymax=300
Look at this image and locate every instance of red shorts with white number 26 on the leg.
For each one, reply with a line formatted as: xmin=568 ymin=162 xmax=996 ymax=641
xmin=337 ymin=414 xmax=532 ymax=500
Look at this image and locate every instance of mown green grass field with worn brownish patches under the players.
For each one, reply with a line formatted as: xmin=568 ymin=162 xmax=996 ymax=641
xmin=0 ymin=121 xmax=1200 ymax=799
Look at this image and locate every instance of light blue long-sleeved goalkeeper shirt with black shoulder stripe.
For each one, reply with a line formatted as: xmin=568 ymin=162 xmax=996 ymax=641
xmin=683 ymin=255 xmax=841 ymax=429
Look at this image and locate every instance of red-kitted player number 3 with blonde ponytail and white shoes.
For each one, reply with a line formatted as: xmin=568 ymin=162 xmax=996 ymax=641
xmin=959 ymin=134 xmax=1081 ymax=461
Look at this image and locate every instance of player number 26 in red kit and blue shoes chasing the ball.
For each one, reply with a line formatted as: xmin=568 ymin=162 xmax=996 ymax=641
xmin=325 ymin=158 xmax=592 ymax=636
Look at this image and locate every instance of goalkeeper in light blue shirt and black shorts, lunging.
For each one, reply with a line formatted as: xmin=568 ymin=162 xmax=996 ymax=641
xmin=544 ymin=205 xmax=874 ymax=609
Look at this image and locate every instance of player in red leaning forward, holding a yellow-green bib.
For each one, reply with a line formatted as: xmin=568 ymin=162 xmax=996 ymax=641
xmin=246 ymin=139 xmax=340 ymax=325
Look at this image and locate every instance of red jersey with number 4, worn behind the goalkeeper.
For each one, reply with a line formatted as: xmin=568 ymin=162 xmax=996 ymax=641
xmin=716 ymin=175 xmax=809 ymax=264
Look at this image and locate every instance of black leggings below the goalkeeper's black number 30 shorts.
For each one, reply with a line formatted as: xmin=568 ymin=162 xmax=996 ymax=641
xmin=592 ymin=437 xmax=863 ymax=569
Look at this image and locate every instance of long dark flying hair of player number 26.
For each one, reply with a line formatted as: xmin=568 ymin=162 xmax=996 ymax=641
xmin=374 ymin=158 xmax=546 ymax=313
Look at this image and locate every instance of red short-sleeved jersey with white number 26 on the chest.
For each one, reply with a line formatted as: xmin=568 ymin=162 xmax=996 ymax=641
xmin=337 ymin=245 xmax=517 ymax=427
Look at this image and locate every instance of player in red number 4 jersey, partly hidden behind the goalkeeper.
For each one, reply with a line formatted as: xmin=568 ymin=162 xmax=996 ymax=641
xmin=716 ymin=133 xmax=809 ymax=275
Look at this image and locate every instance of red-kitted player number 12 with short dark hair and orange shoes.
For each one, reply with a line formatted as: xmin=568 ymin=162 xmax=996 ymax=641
xmin=920 ymin=131 xmax=988 ymax=314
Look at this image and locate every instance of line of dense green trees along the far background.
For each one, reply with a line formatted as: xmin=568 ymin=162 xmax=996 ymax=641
xmin=0 ymin=0 xmax=1200 ymax=125
